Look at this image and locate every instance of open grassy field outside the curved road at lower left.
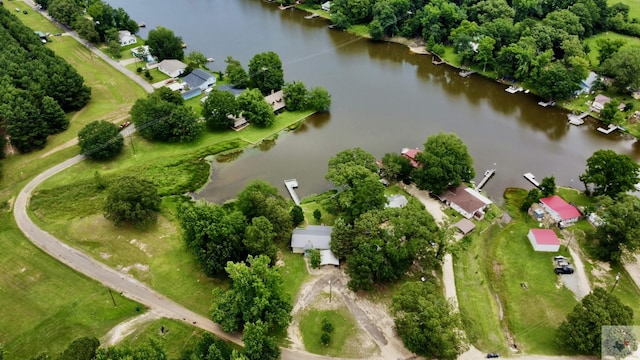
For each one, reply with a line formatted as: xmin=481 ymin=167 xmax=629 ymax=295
xmin=0 ymin=211 xmax=144 ymax=359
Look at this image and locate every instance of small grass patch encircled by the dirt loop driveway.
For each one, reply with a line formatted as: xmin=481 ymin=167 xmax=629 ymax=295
xmin=300 ymin=305 xmax=376 ymax=358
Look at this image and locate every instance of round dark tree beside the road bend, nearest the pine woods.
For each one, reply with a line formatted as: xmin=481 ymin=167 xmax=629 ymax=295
xmin=78 ymin=120 xmax=124 ymax=160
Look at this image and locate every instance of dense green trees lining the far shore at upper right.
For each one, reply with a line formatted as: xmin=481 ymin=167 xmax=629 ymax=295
xmin=300 ymin=0 xmax=640 ymax=99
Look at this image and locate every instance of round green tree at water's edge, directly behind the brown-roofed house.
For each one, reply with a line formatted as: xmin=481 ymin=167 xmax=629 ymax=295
xmin=411 ymin=133 xmax=475 ymax=194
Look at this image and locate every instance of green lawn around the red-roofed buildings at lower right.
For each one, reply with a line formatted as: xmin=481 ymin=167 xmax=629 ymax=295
xmin=453 ymin=189 xmax=640 ymax=355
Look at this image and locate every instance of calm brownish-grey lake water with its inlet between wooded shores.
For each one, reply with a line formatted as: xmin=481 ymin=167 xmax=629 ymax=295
xmin=108 ymin=0 xmax=640 ymax=202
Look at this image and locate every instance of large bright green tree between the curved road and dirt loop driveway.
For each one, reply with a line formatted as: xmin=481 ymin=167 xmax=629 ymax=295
xmin=212 ymin=255 xmax=292 ymax=331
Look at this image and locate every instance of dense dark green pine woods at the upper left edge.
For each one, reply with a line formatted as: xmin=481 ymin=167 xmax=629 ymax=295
xmin=0 ymin=7 xmax=91 ymax=152
